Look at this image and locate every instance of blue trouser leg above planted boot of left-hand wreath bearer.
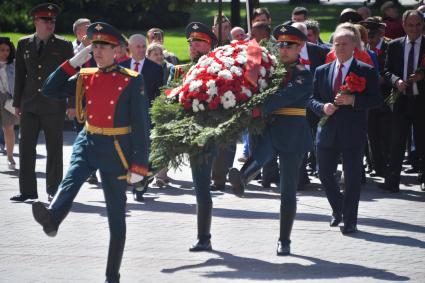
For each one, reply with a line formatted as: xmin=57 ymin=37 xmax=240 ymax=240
xmin=189 ymin=150 xmax=216 ymax=204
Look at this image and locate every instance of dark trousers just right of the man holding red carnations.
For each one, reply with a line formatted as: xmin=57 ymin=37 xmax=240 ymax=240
xmin=367 ymin=107 xmax=391 ymax=174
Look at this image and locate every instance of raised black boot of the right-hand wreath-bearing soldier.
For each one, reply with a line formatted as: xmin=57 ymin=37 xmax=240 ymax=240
xmin=228 ymin=157 xmax=261 ymax=197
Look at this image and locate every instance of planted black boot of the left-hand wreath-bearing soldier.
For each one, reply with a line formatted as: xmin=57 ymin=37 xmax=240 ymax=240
xmin=189 ymin=203 xmax=212 ymax=252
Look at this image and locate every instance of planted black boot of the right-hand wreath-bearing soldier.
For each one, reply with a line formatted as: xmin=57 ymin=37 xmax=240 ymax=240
xmin=276 ymin=205 xmax=296 ymax=256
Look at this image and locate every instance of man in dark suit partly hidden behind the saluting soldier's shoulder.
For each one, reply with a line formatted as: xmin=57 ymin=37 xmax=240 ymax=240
xmin=120 ymin=34 xmax=163 ymax=201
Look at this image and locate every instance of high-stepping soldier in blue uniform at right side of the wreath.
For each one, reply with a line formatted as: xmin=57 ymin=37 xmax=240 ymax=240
xmin=229 ymin=25 xmax=313 ymax=255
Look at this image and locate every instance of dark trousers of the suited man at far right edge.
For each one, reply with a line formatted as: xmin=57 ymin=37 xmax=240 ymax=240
xmin=385 ymin=96 xmax=425 ymax=188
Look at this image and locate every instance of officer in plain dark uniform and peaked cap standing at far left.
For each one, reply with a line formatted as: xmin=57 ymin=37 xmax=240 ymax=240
xmin=11 ymin=3 xmax=73 ymax=201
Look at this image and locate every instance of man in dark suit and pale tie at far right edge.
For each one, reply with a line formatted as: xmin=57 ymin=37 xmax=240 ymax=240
xmin=382 ymin=10 xmax=425 ymax=192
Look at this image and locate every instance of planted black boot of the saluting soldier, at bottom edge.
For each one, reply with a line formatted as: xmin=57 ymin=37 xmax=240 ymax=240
xmin=105 ymin=239 xmax=125 ymax=283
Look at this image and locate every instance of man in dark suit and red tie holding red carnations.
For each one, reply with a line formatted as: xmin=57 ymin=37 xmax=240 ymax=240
xmin=309 ymin=26 xmax=382 ymax=234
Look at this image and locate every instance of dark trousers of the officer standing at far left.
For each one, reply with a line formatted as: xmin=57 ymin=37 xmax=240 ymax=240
xmin=19 ymin=112 xmax=65 ymax=196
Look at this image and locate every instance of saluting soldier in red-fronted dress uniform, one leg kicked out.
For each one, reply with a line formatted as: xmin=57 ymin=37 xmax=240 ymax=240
xmin=32 ymin=22 xmax=149 ymax=283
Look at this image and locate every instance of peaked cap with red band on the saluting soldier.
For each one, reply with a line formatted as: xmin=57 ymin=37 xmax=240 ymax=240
xmin=87 ymin=22 xmax=125 ymax=45
